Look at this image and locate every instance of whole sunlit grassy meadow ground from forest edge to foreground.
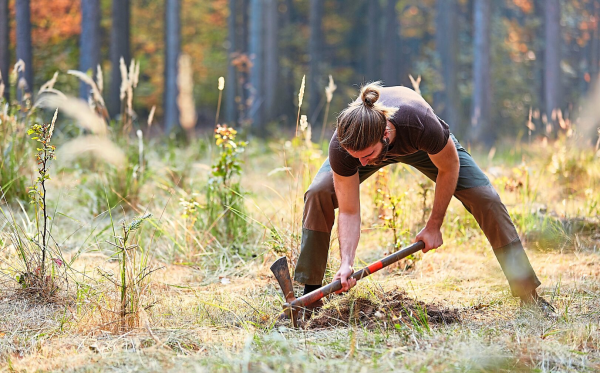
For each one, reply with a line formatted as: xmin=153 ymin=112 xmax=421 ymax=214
xmin=0 ymin=129 xmax=600 ymax=372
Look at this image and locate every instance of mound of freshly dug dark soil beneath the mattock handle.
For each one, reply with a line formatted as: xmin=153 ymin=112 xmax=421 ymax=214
xmin=304 ymin=289 xmax=460 ymax=329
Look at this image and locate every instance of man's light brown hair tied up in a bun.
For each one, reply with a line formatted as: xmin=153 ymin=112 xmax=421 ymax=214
xmin=337 ymin=82 xmax=397 ymax=151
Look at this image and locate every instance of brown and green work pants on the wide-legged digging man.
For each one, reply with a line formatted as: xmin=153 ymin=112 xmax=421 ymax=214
xmin=294 ymin=135 xmax=540 ymax=296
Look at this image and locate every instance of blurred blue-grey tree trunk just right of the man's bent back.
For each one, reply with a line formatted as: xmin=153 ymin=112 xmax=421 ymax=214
xmin=434 ymin=0 xmax=460 ymax=131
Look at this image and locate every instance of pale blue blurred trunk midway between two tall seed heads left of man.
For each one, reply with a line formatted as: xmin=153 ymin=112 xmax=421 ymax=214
xmin=248 ymin=0 xmax=265 ymax=133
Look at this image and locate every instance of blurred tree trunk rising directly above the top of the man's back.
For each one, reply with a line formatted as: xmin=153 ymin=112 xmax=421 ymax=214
xmin=381 ymin=0 xmax=402 ymax=86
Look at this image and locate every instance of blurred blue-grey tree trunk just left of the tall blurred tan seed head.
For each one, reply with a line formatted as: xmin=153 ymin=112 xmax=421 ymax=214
xmin=163 ymin=0 xmax=181 ymax=133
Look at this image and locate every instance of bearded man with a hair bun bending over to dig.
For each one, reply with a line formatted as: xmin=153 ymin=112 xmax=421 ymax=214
xmin=295 ymin=83 xmax=555 ymax=314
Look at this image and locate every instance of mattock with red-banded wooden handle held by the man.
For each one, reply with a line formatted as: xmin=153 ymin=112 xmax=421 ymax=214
xmin=271 ymin=241 xmax=425 ymax=327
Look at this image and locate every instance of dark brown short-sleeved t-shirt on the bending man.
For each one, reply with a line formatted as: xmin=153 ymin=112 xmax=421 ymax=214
xmin=329 ymin=87 xmax=450 ymax=176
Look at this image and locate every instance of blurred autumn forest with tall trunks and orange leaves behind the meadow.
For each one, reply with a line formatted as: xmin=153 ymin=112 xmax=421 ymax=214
xmin=0 ymin=0 xmax=600 ymax=146
